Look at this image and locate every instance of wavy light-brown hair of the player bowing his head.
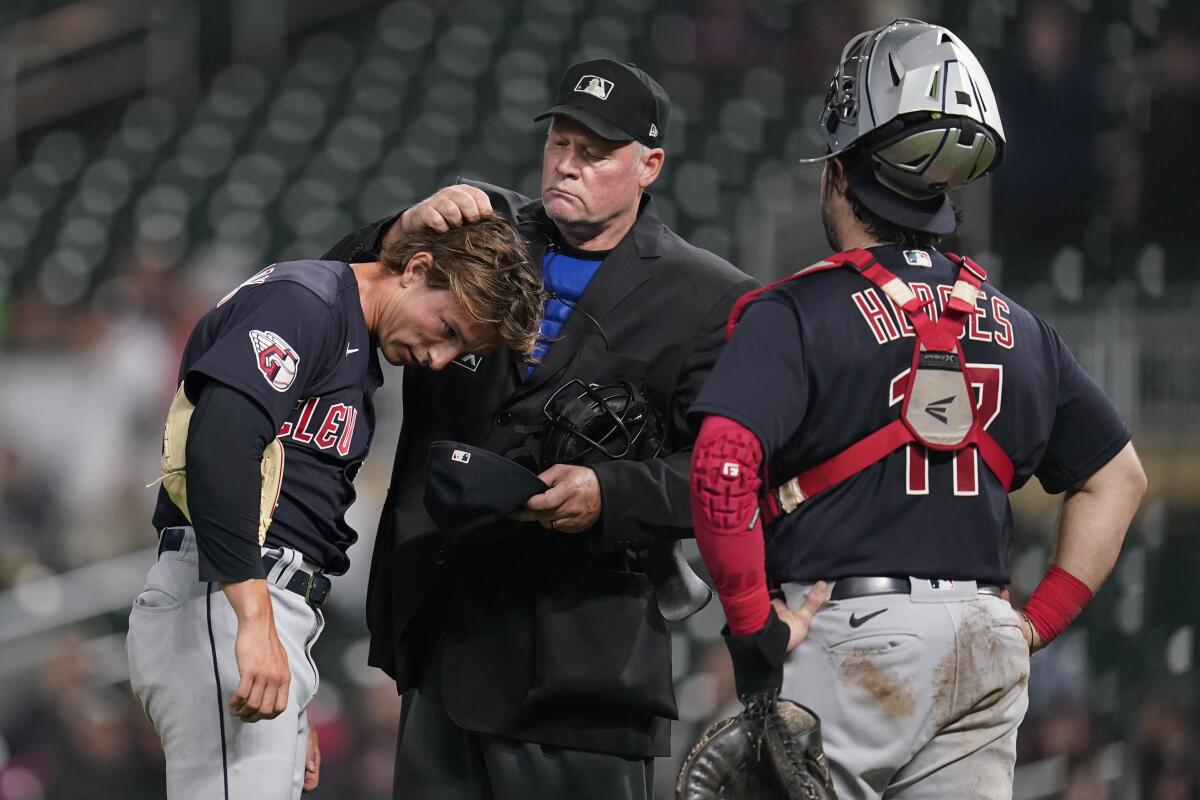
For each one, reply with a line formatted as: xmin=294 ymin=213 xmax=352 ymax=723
xmin=379 ymin=215 xmax=546 ymax=363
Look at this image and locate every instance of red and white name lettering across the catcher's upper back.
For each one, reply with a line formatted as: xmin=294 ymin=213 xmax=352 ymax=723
xmin=850 ymin=282 xmax=1016 ymax=350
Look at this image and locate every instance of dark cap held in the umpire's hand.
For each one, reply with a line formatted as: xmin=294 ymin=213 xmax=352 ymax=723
xmin=425 ymin=441 xmax=550 ymax=535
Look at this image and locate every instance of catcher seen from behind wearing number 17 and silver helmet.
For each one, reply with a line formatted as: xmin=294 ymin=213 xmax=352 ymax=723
xmin=680 ymin=19 xmax=1146 ymax=800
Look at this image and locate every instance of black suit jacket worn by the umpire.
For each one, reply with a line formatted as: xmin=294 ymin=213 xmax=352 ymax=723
xmin=325 ymin=184 xmax=756 ymax=756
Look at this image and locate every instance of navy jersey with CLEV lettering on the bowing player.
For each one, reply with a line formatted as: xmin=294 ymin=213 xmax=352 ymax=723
xmin=154 ymin=261 xmax=383 ymax=575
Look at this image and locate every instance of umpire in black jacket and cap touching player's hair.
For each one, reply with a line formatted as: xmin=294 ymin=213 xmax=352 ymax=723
xmin=330 ymin=60 xmax=755 ymax=800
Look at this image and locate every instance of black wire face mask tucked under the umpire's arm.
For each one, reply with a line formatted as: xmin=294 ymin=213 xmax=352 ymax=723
xmin=540 ymin=378 xmax=664 ymax=469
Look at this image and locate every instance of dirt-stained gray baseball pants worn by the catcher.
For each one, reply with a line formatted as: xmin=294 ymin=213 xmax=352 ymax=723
xmin=782 ymin=578 xmax=1030 ymax=800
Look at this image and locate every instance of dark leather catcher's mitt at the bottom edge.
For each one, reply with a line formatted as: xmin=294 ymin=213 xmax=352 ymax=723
xmin=676 ymin=699 xmax=838 ymax=800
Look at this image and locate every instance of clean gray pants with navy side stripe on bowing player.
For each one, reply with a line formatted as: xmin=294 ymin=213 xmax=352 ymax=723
xmin=126 ymin=529 xmax=324 ymax=800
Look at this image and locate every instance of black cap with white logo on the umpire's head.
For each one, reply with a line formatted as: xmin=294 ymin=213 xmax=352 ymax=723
xmin=534 ymin=59 xmax=671 ymax=148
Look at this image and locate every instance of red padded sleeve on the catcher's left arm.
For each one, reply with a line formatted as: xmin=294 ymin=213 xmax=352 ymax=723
xmin=691 ymin=416 xmax=770 ymax=636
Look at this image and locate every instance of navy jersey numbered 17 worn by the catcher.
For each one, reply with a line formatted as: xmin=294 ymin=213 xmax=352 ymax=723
xmin=691 ymin=246 xmax=1130 ymax=583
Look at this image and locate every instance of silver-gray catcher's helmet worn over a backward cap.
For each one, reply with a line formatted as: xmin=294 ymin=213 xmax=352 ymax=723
xmin=808 ymin=19 xmax=1004 ymax=234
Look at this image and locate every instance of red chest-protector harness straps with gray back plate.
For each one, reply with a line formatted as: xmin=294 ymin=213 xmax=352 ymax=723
xmin=726 ymin=249 xmax=1014 ymax=521
